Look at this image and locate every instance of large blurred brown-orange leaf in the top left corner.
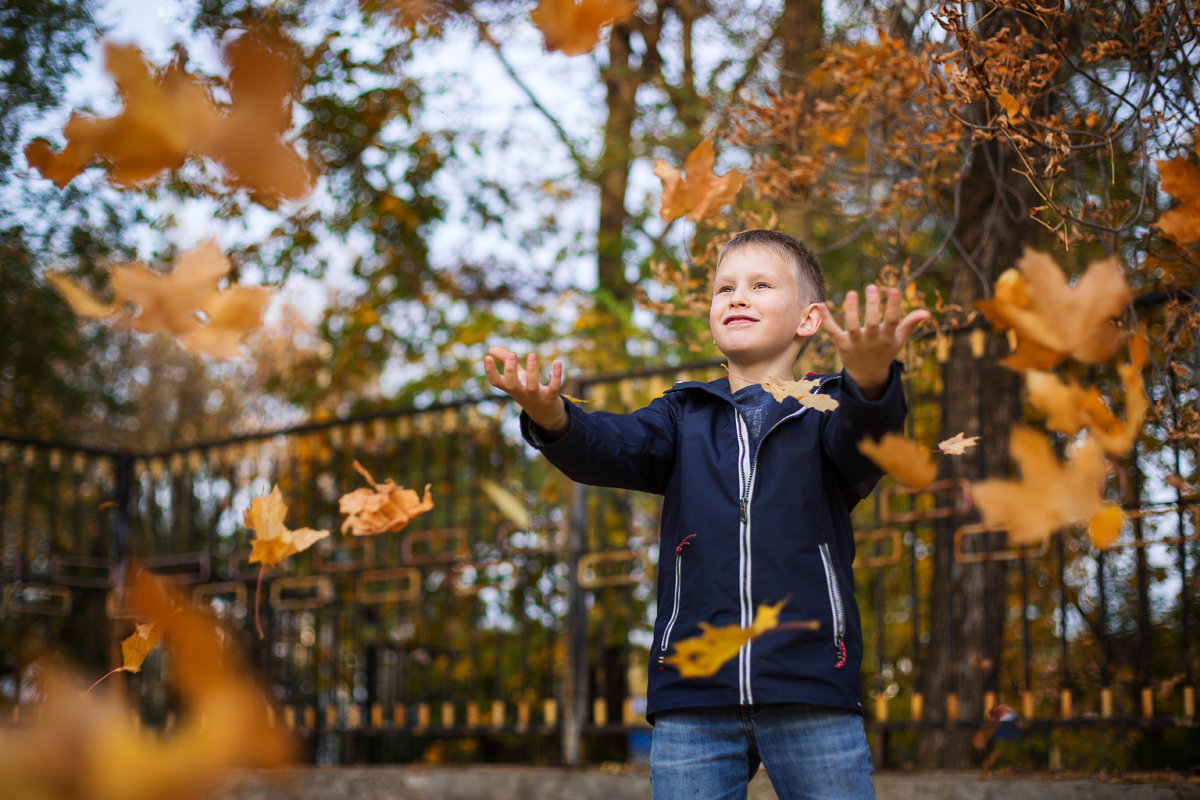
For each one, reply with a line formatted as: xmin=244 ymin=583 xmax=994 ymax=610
xmin=25 ymin=34 xmax=313 ymax=206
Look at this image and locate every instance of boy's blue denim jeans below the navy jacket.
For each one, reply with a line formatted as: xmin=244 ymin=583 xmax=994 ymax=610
xmin=650 ymin=704 xmax=875 ymax=800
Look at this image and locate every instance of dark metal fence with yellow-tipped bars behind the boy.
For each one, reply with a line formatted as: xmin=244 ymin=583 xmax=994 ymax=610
xmin=0 ymin=314 xmax=1200 ymax=764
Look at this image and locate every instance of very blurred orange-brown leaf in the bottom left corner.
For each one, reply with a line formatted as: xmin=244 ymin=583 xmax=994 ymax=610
xmin=0 ymin=573 xmax=294 ymax=800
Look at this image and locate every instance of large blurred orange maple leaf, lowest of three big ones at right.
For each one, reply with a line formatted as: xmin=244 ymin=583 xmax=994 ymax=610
xmin=971 ymin=427 xmax=1111 ymax=545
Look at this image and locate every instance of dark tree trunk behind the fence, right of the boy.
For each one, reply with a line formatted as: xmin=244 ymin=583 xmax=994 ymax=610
xmin=916 ymin=134 xmax=1037 ymax=769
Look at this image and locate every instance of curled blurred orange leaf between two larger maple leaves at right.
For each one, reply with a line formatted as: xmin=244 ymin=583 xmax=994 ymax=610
xmin=1025 ymin=331 xmax=1150 ymax=456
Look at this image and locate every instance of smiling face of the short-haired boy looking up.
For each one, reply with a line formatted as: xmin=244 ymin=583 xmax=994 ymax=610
xmin=708 ymin=247 xmax=816 ymax=367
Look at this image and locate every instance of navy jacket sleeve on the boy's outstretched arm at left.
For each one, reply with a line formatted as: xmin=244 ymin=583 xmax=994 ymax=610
xmin=521 ymin=397 xmax=679 ymax=494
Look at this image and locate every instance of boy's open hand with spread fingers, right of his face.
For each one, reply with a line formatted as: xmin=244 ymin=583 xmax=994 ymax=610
xmin=817 ymin=284 xmax=929 ymax=399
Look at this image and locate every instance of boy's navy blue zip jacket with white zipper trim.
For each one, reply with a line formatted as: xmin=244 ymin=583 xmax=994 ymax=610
xmin=521 ymin=363 xmax=906 ymax=717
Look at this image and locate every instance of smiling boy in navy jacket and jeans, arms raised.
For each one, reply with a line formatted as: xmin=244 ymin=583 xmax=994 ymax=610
xmin=484 ymin=230 xmax=929 ymax=800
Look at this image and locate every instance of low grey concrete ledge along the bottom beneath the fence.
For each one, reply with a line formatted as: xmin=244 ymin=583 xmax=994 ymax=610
xmin=220 ymin=765 xmax=1200 ymax=800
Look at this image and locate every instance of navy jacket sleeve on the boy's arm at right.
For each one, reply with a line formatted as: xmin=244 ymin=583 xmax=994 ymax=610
xmin=821 ymin=361 xmax=908 ymax=499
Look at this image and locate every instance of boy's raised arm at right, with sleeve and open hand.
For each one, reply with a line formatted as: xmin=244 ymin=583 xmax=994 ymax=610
xmin=818 ymin=285 xmax=929 ymax=497
